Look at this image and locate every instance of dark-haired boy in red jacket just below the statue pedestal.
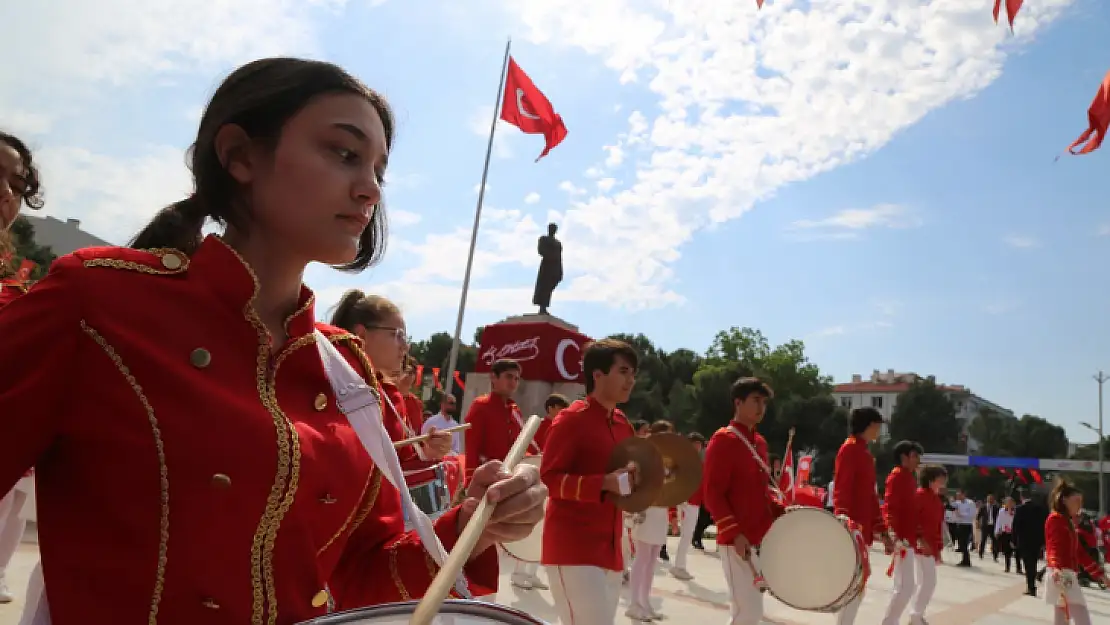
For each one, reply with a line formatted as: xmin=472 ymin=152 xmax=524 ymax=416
xmin=463 ymin=359 xmax=539 ymax=481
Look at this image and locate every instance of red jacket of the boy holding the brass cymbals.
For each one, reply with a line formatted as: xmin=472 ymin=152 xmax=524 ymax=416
xmin=539 ymin=397 xmax=634 ymax=571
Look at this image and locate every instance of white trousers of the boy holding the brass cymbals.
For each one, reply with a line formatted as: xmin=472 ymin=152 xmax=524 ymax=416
xmin=544 ymin=566 xmax=620 ymax=625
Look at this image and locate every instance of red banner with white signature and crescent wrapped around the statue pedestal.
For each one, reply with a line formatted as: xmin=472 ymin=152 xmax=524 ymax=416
xmin=474 ymin=322 xmax=592 ymax=383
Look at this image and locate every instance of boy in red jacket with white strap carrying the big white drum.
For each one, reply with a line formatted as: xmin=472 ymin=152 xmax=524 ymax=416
xmin=703 ymin=377 xmax=783 ymax=625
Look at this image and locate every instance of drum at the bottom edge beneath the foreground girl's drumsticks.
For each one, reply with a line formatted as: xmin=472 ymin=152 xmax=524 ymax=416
xmin=301 ymin=599 xmax=546 ymax=625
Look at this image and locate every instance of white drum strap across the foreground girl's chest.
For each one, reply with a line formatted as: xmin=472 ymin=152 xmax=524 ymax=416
xmin=316 ymin=330 xmax=471 ymax=598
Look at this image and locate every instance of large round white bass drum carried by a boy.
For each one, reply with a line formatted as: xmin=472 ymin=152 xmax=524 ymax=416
xmin=759 ymin=507 xmax=870 ymax=613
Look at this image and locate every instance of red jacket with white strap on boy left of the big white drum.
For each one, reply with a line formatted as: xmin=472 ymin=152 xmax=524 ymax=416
xmin=702 ymin=422 xmax=784 ymax=546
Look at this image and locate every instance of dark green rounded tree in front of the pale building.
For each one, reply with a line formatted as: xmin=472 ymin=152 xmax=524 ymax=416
xmin=889 ymin=376 xmax=960 ymax=454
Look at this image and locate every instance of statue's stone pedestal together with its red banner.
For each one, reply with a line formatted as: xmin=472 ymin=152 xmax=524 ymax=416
xmin=461 ymin=313 xmax=591 ymax=417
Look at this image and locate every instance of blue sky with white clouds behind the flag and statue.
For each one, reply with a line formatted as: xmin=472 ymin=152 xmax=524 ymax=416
xmin=0 ymin=0 xmax=1110 ymax=443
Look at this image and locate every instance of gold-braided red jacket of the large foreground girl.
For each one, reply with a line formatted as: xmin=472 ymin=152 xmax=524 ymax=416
xmin=0 ymin=236 xmax=497 ymax=625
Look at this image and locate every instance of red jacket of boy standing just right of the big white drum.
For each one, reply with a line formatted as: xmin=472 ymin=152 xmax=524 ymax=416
xmin=833 ymin=436 xmax=885 ymax=545
